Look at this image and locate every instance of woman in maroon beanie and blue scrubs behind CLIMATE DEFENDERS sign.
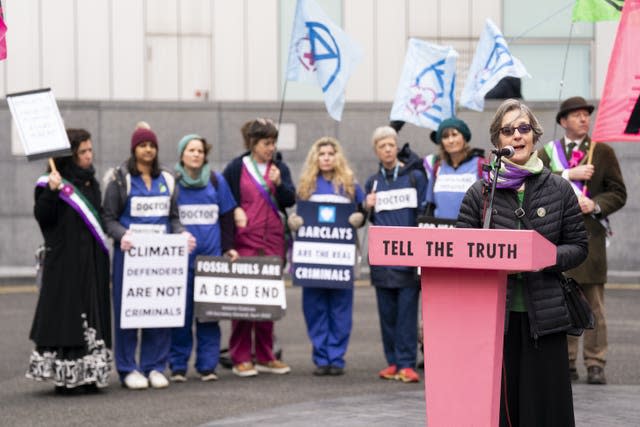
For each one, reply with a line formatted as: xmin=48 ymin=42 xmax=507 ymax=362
xmin=103 ymin=124 xmax=195 ymax=389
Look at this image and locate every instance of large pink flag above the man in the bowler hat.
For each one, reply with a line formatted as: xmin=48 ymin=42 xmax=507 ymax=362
xmin=591 ymin=0 xmax=640 ymax=142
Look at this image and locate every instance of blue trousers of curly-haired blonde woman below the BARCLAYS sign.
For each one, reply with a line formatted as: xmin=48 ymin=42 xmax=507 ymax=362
xmin=302 ymin=288 xmax=353 ymax=368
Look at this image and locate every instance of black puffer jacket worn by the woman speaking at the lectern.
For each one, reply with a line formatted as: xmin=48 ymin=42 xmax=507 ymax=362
xmin=457 ymin=168 xmax=588 ymax=338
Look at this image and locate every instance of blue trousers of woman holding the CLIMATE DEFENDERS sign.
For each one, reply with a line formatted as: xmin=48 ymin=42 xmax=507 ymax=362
xmin=112 ymin=248 xmax=171 ymax=381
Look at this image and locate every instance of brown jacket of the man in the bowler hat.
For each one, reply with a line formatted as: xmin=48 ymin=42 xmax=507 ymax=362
xmin=538 ymin=136 xmax=627 ymax=283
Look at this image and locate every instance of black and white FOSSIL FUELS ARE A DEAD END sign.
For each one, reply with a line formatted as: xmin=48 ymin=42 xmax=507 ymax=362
xmin=193 ymin=256 xmax=287 ymax=322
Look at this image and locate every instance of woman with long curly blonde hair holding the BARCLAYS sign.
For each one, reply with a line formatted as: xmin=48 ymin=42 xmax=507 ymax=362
xmin=289 ymin=137 xmax=364 ymax=375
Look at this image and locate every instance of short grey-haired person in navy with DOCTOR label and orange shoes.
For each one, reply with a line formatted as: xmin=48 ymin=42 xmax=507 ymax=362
xmin=365 ymin=126 xmax=427 ymax=383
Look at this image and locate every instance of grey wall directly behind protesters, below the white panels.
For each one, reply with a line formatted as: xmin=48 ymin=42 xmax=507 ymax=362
xmin=0 ymin=101 xmax=640 ymax=282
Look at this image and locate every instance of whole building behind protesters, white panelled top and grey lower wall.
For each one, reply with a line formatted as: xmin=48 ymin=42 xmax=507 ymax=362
xmin=0 ymin=0 xmax=640 ymax=283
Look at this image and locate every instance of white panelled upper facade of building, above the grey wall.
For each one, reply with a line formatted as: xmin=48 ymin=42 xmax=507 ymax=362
xmin=0 ymin=0 xmax=616 ymax=102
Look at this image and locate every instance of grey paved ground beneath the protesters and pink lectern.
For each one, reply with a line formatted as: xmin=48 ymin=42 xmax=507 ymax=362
xmin=0 ymin=285 xmax=640 ymax=426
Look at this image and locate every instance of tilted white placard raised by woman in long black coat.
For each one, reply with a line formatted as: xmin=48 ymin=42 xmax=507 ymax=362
xmin=7 ymin=88 xmax=71 ymax=160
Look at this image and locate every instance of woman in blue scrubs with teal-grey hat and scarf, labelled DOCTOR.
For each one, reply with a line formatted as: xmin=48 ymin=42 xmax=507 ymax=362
xmin=169 ymin=134 xmax=238 ymax=382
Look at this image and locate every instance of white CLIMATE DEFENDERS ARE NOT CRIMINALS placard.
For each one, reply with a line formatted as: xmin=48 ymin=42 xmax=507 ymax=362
xmin=120 ymin=234 xmax=189 ymax=329
